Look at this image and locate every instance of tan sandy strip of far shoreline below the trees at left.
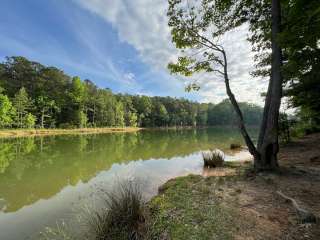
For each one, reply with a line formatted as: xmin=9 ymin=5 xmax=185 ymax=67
xmin=0 ymin=127 xmax=143 ymax=139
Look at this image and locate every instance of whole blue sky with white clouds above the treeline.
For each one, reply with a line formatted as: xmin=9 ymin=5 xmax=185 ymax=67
xmin=0 ymin=0 xmax=267 ymax=105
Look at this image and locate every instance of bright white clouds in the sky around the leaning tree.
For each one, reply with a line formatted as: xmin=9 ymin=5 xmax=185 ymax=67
xmin=74 ymin=0 xmax=266 ymax=104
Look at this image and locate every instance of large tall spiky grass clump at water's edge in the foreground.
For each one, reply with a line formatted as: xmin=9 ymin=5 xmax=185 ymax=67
xmin=87 ymin=181 xmax=146 ymax=240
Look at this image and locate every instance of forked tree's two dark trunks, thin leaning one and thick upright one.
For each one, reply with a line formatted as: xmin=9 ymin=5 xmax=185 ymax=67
xmin=220 ymin=0 xmax=282 ymax=171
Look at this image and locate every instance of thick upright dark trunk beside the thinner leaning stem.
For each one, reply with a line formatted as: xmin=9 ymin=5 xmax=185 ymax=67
xmin=255 ymin=0 xmax=282 ymax=170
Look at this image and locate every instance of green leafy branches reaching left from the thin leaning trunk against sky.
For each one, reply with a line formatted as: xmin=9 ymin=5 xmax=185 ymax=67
xmin=167 ymin=0 xmax=224 ymax=80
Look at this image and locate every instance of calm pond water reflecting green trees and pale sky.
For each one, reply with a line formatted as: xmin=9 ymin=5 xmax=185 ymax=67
xmin=0 ymin=128 xmax=254 ymax=240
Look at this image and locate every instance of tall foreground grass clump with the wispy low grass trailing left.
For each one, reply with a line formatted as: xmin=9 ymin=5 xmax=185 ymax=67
xmin=40 ymin=180 xmax=147 ymax=240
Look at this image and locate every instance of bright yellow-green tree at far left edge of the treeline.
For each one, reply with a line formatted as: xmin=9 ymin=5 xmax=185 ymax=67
xmin=0 ymin=94 xmax=16 ymax=128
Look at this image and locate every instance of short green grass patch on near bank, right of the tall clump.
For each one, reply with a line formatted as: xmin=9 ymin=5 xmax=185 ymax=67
xmin=149 ymin=175 xmax=242 ymax=240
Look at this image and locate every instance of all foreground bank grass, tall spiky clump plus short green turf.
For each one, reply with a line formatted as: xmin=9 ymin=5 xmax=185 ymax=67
xmin=38 ymin=162 xmax=251 ymax=240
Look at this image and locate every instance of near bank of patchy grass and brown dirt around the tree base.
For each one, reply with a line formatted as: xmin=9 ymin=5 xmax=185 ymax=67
xmin=149 ymin=134 xmax=320 ymax=240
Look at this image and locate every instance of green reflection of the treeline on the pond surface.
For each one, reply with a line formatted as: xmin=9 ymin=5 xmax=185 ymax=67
xmin=0 ymin=129 xmax=258 ymax=211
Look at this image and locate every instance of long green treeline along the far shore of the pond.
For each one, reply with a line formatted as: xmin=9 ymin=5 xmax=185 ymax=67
xmin=0 ymin=57 xmax=262 ymax=128
